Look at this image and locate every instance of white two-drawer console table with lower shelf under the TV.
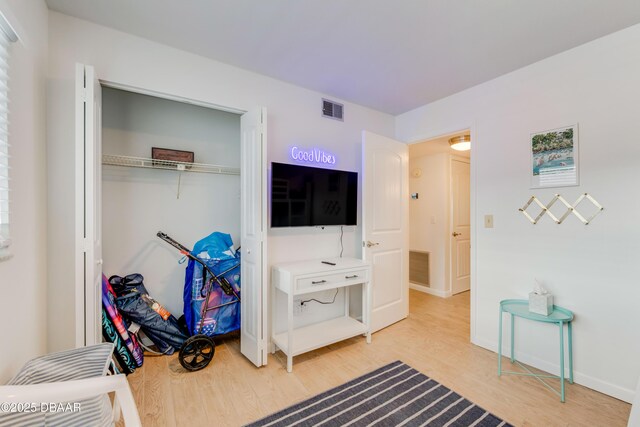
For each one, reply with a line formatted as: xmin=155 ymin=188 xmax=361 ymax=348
xmin=271 ymin=258 xmax=371 ymax=372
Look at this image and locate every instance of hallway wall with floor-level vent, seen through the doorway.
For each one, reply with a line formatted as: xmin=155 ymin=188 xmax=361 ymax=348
xmin=409 ymin=153 xmax=451 ymax=297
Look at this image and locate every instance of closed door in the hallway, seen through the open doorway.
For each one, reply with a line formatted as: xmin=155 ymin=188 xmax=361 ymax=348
xmin=451 ymin=159 xmax=471 ymax=295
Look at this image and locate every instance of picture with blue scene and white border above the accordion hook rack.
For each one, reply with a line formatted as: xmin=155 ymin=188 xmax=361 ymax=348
xmin=529 ymin=123 xmax=580 ymax=188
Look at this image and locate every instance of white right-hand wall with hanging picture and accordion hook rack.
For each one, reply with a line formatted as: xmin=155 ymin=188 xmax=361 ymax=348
xmin=396 ymin=25 xmax=640 ymax=401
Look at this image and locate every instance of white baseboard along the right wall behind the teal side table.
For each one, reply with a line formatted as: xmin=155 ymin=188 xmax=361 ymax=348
xmin=472 ymin=337 xmax=636 ymax=403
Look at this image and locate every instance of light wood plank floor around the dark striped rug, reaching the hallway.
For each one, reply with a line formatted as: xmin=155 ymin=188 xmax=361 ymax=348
xmin=129 ymin=290 xmax=631 ymax=427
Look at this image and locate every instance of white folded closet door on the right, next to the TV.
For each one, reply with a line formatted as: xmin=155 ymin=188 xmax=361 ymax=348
xmin=240 ymin=108 xmax=268 ymax=366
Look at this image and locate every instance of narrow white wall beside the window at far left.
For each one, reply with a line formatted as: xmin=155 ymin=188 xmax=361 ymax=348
xmin=0 ymin=0 xmax=47 ymax=384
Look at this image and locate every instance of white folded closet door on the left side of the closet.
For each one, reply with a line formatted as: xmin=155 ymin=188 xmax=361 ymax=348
xmin=75 ymin=64 xmax=102 ymax=346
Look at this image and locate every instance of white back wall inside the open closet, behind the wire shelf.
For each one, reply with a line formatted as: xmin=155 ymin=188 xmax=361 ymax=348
xmin=102 ymin=88 xmax=240 ymax=316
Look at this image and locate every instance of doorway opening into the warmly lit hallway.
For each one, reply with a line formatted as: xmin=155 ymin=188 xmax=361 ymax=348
xmin=409 ymin=129 xmax=473 ymax=320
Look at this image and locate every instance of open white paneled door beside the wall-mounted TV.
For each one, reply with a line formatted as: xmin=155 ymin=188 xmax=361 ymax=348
xmin=362 ymin=131 xmax=409 ymax=332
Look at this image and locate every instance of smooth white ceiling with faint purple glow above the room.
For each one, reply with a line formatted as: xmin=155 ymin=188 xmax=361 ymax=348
xmin=47 ymin=0 xmax=640 ymax=115
